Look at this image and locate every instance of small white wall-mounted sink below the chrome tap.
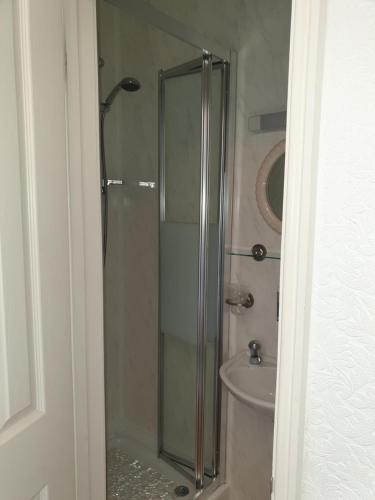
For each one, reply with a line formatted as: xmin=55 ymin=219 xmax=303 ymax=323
xmin=220 ymin=350 xmax=276 ymax=414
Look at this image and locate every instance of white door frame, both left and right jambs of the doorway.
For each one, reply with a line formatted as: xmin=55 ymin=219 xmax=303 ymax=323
xmin=64 ymin=0 xmax=327 ymax=500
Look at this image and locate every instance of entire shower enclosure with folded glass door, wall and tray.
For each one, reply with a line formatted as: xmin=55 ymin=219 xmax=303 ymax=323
xmin=98 ymin=0 xmax=231 ymax=500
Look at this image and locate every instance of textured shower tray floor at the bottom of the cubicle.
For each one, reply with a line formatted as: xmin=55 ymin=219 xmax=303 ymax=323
xmin=107 ymin=448 xmax=191 ymax=500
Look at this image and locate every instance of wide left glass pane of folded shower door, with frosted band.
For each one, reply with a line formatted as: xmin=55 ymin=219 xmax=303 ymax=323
xmin=160 ymin=66 xmax=201 ymax=468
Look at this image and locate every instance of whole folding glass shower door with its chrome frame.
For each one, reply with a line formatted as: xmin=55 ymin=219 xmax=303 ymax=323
xmin=159 ymin=54 xmax=227 ymax=488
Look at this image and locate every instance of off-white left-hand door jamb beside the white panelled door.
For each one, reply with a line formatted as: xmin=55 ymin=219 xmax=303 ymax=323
xmin=64 ymin=0 xmax=106 ymax=500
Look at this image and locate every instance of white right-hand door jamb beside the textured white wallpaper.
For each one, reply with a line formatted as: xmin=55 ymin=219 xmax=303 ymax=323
xmin=272 ymin=0 xmax=327 ymax=500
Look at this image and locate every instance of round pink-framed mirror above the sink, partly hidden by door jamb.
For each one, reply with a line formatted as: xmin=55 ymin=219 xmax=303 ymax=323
xmin=256 ymin=140 xmax=285 ymax=233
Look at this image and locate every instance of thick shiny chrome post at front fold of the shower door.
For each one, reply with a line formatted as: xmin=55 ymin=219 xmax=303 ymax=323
xmin=195 ymin=53 xmax=212 ymax=489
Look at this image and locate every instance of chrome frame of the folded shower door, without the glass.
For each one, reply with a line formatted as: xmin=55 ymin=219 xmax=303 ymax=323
xmin=158 ymin=51 xmax=229 ymax=490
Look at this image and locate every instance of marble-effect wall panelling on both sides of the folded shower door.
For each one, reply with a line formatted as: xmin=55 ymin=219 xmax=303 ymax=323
xmin=101 ymin=0 xmax=290 ymax=500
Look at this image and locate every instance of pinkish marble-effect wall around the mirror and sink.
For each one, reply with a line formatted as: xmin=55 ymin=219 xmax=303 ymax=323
xmin=227 ymin=0 xmax=290 ymax=492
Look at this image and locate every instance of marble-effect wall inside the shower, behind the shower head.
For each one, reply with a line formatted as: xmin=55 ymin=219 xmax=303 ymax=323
xmin=99 ymin=1 xmax=198 ymax=446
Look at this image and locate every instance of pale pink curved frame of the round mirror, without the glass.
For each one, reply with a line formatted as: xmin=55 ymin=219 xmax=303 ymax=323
xmin=255 ymin=139 xmax=285 ymax=234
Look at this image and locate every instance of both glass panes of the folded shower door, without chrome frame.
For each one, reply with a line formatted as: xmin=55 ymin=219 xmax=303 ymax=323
xmin=159 ymin=60 xmax=223 ymax=482
